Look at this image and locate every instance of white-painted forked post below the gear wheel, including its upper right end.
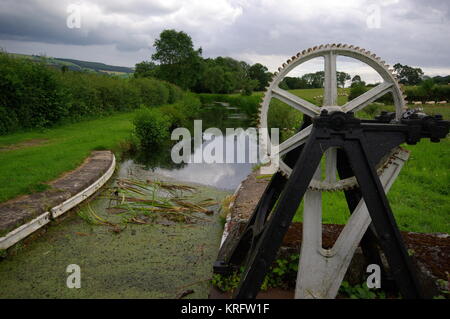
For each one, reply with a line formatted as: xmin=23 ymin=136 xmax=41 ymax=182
xmin=295 ymin=150 xmax=409 ymax=299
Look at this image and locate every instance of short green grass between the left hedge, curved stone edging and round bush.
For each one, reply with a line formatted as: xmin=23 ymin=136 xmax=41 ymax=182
xmin=0 ymin=112 xmax=134 ymax=202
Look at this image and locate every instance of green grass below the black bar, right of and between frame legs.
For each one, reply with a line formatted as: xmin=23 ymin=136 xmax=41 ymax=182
xmin=295 ymin=138 xmax=450 ymax=233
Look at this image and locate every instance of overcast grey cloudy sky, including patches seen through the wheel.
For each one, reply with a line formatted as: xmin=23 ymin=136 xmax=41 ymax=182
xmin=0 ymin=0 xmax=450 ymax=81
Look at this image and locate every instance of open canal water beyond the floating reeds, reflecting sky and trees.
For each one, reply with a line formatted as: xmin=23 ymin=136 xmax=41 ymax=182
xmin=129 ymin=104 xmax=256 ymax=190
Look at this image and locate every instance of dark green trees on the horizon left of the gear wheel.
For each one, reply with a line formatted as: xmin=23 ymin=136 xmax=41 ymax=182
xmin=134 ymin=30 xmax=272 ymax=95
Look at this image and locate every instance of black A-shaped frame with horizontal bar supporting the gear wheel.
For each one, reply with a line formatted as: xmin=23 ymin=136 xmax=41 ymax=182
xmin=214 ymin=111 xmax=449 ymax=298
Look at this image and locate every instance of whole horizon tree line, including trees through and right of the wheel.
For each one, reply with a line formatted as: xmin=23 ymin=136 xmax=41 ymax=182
xmin=134 ymin=30 xmax=450 ymax=95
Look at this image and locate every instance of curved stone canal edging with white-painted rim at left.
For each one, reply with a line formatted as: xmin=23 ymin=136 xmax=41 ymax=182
xmin=0 ymin=151 xmax=116 ymax=250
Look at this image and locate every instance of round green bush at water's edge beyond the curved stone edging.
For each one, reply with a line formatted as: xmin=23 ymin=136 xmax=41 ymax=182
xmin=133 ymin=108 xmax=171 ymax=148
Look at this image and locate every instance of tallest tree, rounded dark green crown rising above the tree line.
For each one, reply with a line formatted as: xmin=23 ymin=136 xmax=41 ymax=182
xmin=152 ymin=30 xmax=202 ymax=89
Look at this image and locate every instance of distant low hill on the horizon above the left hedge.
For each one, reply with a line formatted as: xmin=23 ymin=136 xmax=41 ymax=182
xmin=13 ymin=53 xmax=134 ymax=76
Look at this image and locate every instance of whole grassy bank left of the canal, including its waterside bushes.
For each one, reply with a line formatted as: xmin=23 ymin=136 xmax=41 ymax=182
xmin=0 ymin=93 xmax=200 ymax=202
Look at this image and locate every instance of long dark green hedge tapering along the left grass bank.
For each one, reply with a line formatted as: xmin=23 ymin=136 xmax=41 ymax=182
xmin=0 ymin=52 xmax=183 ymax=135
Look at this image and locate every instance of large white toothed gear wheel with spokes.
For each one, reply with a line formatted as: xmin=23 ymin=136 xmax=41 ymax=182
xmin=259 ymin=44 xmax=406 ymax=191
